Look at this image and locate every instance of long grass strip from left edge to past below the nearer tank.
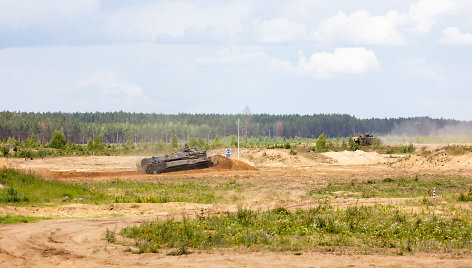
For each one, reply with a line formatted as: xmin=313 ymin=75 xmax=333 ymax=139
xmin=0 ymin=169 xmax=220 ymax=205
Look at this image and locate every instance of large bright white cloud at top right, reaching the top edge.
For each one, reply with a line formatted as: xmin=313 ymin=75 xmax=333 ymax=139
xmin=314 ymin=0 xmax=465 ymax=45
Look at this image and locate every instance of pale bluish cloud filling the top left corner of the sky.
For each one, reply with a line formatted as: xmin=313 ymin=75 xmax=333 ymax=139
xmin=0 ymin=0 xmax=100 ymax=30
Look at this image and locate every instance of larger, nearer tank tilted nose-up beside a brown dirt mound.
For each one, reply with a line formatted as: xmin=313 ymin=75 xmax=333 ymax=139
xmin=136 ymin=145 xmax=213 ymax=174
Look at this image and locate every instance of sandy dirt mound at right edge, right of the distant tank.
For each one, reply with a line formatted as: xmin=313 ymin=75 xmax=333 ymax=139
xmin=390 ymin=151 xmax=472 ymax=169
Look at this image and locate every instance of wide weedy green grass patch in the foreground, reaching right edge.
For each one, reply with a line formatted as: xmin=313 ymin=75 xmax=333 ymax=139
xmin=121 ymin=205 xmax=472 ymax=253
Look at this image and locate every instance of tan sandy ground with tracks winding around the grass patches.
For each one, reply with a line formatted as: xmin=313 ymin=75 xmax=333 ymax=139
xmin=0 ymin=150 xmax=472 ymax=267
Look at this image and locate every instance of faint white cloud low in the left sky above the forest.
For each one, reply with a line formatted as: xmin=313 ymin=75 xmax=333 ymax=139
xmin=79 ymin=71 xmax=142 ymax=100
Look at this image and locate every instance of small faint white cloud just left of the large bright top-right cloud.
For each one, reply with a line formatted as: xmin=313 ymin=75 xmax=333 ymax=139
xmin=255 ymin=18 xmax=306 ymax=43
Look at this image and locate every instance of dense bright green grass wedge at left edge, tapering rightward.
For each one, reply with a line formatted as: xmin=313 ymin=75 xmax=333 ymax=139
xmin=0 ymin=169 xmax=106 ymax=204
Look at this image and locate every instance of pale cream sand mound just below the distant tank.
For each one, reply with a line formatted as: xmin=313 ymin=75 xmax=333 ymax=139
xmin=323 ymin=150 xmax=387 ymax=165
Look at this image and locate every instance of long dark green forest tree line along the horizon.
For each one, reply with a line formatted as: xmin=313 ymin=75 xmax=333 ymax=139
xmin=0 ymin=111 xmax=472 ymax=144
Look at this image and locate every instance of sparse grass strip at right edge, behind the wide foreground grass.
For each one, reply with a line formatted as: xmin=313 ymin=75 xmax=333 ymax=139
xmin=307 ymin=174 xmax=472 ymax=199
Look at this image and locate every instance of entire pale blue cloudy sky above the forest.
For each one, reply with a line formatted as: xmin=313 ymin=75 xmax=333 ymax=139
xmin=0 ymin=0 xmax=472 ymax=120
